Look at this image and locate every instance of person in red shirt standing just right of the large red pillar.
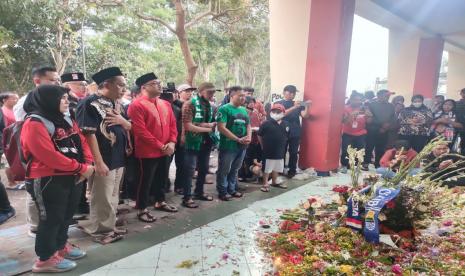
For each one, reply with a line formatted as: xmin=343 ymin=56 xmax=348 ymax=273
xmin=340 ymin=91 xmax=372 ymax=173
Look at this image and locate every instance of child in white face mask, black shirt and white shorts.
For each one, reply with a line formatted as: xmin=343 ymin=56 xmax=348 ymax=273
xmin=258 ymin=103 xmax=290 ymax=192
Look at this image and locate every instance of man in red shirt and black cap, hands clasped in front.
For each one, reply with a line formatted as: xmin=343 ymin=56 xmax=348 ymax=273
xmin=128 ymin=73 xmax=178 ymax=222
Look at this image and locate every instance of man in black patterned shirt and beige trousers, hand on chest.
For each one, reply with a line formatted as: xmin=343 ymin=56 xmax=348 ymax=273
xmin=76 ymin=67 xmax=131 ymax=244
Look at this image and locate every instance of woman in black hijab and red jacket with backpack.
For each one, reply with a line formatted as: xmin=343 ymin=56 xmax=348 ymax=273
xmin=21 ymin=85 xmax=94 ymax=273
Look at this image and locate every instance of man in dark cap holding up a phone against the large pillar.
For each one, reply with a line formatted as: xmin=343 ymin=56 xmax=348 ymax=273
xmin=276 ymin=85 xmax=311 ymax=178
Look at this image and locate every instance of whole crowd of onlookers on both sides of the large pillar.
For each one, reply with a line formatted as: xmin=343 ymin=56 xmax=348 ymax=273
xmin=0 ymin=67 xmax=465 ymax=272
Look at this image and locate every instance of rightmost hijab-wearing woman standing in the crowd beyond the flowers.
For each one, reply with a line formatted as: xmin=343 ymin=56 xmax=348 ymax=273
xmin=431 ymin=99 xmax=463 ymax=149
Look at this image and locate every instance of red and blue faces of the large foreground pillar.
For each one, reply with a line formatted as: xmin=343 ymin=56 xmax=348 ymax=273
xmin=300 ymin=0 xmax=355 ymax=172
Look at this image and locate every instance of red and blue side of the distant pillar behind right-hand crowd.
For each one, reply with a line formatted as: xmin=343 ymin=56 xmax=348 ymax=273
xmin=413 ymin=37 xmax=444 ymax=99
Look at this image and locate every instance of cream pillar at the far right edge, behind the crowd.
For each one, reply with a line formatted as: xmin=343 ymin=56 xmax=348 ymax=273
xmin=446 ymin=51 xmax=465 ymax=100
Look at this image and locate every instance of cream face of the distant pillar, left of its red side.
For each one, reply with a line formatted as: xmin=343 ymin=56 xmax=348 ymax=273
xmin=387 ymin=29 xmax=420 ymax=103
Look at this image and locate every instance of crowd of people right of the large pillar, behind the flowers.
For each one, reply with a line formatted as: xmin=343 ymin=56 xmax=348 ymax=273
xmin=340 ymin=89 xmax=465 ymax=185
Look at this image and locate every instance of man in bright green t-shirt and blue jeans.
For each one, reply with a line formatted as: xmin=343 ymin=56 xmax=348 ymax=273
xmin=216 ymin=86 xmax=252 ymax=201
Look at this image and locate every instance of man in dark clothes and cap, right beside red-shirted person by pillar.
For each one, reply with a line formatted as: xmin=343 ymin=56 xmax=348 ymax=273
xmin=362 ymin=89 xmax=396 ymax=171
